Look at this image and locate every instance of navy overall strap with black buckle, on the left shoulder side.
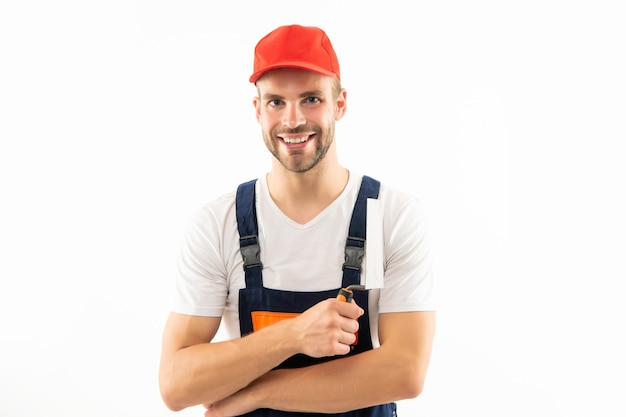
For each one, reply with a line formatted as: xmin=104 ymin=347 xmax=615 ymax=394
xmin=235 ymin=179 xmax=263 ymax=288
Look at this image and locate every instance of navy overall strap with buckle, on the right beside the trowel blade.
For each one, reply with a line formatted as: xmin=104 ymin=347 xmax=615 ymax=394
xmin=341 ymin=175 xmax=380 ymax=288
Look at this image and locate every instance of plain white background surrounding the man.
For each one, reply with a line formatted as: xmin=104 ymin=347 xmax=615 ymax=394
xmin=0 ymin=0 xmax=626 ymax=417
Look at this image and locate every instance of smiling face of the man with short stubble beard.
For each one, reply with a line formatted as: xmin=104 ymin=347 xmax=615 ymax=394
xmin=254 ymin=69 xmax=346 ymax=173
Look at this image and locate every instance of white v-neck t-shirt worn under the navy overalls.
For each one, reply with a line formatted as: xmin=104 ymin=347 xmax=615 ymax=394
xmin=172 ymin=174 xmax=435 ymax=347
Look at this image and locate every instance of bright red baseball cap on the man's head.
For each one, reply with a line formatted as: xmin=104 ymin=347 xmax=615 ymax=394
xmin=250 ymin=25 xmax=340 ymax=83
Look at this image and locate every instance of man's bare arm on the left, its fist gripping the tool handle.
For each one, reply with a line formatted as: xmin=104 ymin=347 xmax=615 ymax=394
xmin=159 ymin=300 xmax=362 ymax=411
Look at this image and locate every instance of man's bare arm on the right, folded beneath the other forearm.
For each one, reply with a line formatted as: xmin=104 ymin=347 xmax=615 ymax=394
xmin=207 ymin=312 xmax=435 ymax=416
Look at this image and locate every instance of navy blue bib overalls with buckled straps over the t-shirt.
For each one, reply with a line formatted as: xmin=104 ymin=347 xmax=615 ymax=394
xmin=236 ymin=176 xmax=396 ymax=417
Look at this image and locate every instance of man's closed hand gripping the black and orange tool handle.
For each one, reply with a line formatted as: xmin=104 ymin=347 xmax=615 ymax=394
xmin=290 ymin=298 xmax=364 ymax=358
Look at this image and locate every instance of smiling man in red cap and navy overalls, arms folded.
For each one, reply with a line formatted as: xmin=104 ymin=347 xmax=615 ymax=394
xmin=159 ymin=25 xmax=435 ymax=417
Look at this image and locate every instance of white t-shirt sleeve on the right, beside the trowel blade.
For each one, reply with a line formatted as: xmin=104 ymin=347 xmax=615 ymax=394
xmin=379 ymin=189 xmax=436 ymax=313
